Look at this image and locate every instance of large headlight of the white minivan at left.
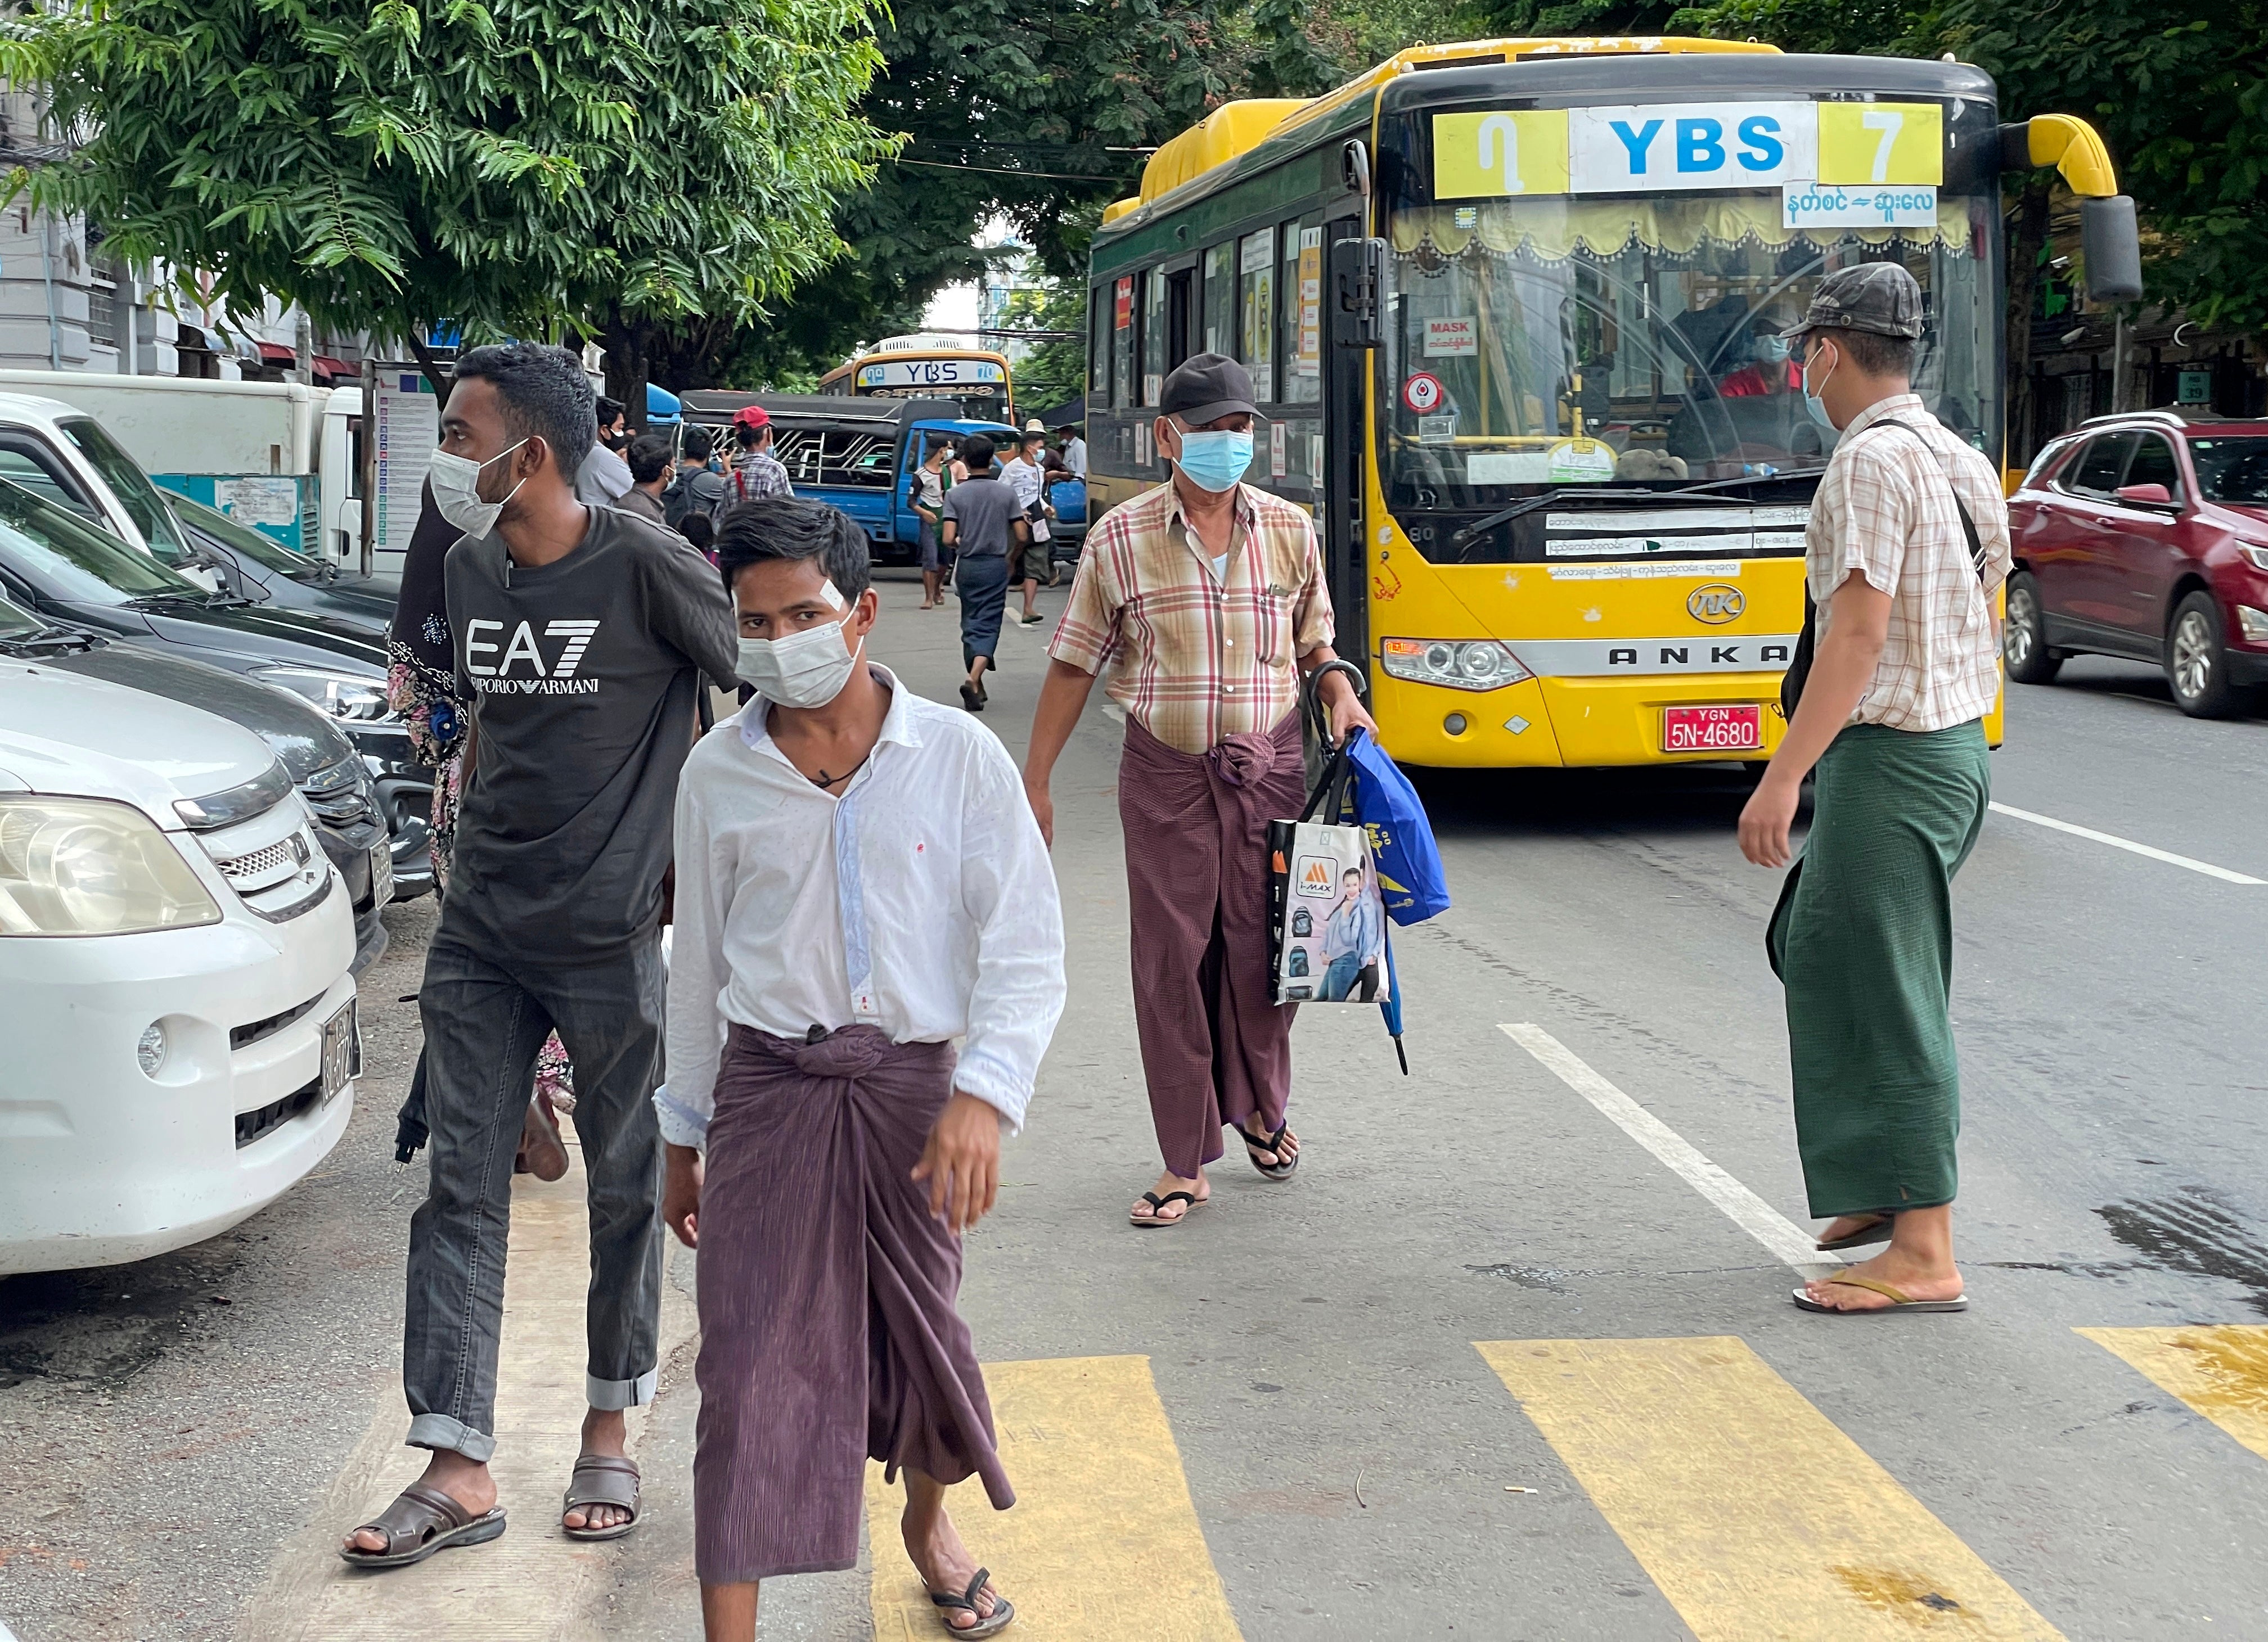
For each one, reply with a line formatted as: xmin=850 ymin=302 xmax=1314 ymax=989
xmin=0 ymin=799 xmax=220 ymax=937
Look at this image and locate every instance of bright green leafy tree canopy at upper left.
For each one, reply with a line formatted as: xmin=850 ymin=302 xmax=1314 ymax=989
xmin=0 ymin=0 xmax=892 ymax=413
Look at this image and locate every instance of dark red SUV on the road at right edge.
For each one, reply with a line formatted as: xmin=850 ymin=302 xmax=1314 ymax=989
xmin=2005 ymin=411 xmax=2268 ymax=719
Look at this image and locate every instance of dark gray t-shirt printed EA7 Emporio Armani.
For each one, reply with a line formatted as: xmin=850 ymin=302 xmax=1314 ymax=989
xmin=442 ymin=508 xmax=737 ymax=964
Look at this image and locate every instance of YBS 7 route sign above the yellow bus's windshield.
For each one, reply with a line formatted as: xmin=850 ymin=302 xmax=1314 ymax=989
xmin=1433 ymin=102 xmax=1943 ymax=200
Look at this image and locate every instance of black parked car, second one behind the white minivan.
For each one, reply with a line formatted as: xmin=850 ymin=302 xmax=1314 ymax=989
xmin=0 ymin=479 xmax=433 ymax=898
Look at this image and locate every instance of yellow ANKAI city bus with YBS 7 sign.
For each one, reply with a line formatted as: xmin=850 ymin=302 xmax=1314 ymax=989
xmin=1086 ymin=37 xmax=2139 ymax=766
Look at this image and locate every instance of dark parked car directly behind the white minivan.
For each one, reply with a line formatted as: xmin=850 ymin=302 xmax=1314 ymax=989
xmin=0 ymin=599 xmax=395 ymax=975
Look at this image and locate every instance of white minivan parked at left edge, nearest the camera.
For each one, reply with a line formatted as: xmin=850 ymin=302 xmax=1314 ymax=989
xmin=0 ymin=662 xmax=361 ymax=1275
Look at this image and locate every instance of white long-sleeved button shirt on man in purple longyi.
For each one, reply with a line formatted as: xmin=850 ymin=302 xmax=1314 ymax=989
xmin=653 ymin=667 xmax=1064 ymax=1145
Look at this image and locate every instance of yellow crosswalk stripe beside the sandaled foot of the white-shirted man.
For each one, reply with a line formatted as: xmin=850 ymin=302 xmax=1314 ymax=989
xmin=866 ymin=1356 xmax=1241 ymax=1642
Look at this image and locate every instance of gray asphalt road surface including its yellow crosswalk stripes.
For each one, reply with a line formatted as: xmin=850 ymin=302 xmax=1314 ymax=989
xmin=0 ymin=580 xmax=2268 ymax=1642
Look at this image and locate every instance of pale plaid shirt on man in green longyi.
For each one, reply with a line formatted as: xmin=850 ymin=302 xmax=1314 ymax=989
xmin=1803 ymin=393 xmax=2012 ymax=730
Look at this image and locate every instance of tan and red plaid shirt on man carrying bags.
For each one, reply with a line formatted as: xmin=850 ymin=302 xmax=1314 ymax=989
xmin=1048 ymin=483 xmax=1334 ymax=753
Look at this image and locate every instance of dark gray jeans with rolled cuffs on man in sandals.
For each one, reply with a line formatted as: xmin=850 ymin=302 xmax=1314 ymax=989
xmin=402 ymin=926 xmax=662 ymax=1460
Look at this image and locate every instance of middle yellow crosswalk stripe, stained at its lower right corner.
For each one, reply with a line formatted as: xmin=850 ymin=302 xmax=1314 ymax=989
xmin=1477 ymin=1338 xmax=2059 ymax=1642
